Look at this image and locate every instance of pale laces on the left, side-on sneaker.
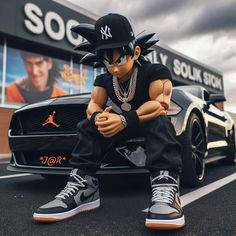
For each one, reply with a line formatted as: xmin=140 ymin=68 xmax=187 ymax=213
xmin=56 ymin=171 xmax=87 ymax=199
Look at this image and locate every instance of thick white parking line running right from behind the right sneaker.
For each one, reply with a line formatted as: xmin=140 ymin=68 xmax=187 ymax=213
xmin=142 ymin=173 xmax=236 ymax=212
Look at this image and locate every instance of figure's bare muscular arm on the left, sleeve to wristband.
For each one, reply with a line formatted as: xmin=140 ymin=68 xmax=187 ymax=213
xmin=87 ymin=87 xmax=107 ymax=119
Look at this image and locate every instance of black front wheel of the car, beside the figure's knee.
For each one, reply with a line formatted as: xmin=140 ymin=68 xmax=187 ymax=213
xmin=181 ymin=113 xmax=206 ymax=187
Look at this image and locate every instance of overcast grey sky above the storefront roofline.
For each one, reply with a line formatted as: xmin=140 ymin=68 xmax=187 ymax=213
xmin=69 ymin=0 xmax=236 ymax=113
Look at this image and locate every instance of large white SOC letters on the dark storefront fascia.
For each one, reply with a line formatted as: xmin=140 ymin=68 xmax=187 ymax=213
xmin=24 ymin=3 xmax=82 ymax=45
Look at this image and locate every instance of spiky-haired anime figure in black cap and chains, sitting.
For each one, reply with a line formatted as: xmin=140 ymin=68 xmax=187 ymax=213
xmin=33 ymin=14 xmax=185 ymax=229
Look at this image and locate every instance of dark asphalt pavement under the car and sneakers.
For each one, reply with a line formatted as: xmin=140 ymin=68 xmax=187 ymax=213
xmin=0 ymin=159 xmax=236 ymax=236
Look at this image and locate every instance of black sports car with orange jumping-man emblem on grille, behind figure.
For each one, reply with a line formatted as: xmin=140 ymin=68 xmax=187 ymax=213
xmin=8 ymin=86 xmax=235 ymax=186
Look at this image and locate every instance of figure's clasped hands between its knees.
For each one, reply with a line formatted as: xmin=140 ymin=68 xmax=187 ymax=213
xmin=96 ymin=107 xmax=124 ymax=138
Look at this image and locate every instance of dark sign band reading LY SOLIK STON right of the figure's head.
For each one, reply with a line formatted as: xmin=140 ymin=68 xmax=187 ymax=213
xmin=149 ymin=46 xmax=223 ymax=92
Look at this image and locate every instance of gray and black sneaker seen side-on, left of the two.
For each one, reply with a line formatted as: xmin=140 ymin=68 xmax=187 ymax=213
xmin=33 ymin=169 xmax=100 ymax=222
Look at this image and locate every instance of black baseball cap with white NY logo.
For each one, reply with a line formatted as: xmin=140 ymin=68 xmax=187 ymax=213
xmin=95 ymin=13 xmax=135 ymax=50
